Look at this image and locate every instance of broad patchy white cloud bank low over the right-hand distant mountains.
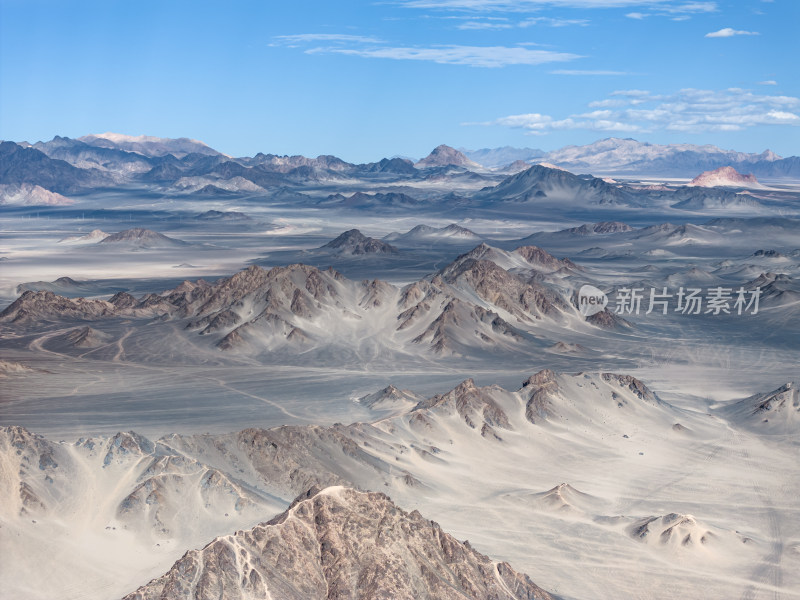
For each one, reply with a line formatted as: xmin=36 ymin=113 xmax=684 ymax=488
xmin=471 ymin=88 xmax=800 ymax=135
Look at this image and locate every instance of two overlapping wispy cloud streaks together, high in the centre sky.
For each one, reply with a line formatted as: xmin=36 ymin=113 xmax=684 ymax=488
xmin=273 ymin=33 xmax=581 ymax=68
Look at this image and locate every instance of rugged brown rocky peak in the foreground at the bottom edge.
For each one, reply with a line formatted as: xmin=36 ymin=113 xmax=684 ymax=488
xmin=125 ymin=487 xmax=552 ymax=600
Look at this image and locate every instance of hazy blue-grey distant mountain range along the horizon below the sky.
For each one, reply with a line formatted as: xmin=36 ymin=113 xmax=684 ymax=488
xmin=0 ymin=133 xmax=800 ymax=209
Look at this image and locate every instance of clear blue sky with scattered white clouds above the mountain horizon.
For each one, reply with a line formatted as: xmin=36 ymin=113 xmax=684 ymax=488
xmin=0 ymin=0 xmax=800 ymax=161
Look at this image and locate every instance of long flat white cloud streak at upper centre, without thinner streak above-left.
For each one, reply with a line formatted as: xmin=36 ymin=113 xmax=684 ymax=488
xmin=306 ymin=46 xmax=580 ymax=67
